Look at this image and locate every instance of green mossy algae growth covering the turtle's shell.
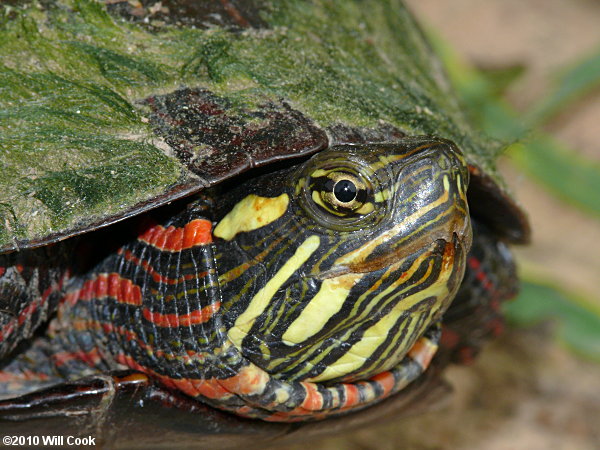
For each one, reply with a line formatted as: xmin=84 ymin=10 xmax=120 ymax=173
xmin=0 ymin=0 xmax=497 ymax=247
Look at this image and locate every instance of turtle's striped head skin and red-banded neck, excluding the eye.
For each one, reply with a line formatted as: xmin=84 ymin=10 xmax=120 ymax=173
xmin=0 ymin=138 xmax=471 ymax=421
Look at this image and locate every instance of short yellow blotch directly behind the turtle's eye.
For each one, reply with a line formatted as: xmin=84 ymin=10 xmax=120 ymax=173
xmin=213 ymin=194 xmax=290 ymax=241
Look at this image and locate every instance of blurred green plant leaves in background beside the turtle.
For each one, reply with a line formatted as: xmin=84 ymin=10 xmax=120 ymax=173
xmin=433 ymin=36 xmax=600 ymax=362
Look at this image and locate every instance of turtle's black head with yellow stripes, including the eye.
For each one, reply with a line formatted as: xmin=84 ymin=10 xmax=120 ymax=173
xmin=214 ymin=138 xmax=471 ymax=382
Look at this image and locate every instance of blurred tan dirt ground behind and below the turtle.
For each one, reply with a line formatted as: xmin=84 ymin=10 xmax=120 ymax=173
xmin=276 ymin=0 xmax=600 ymax=450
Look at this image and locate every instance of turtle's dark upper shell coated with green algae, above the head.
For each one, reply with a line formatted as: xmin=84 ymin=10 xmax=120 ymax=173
xmin=0 ymin=0 xmax=529 ymax=252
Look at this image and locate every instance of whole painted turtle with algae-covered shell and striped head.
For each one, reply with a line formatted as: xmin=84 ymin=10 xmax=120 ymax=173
xmin=0 ymin=0 xmax=529 ymax=445
